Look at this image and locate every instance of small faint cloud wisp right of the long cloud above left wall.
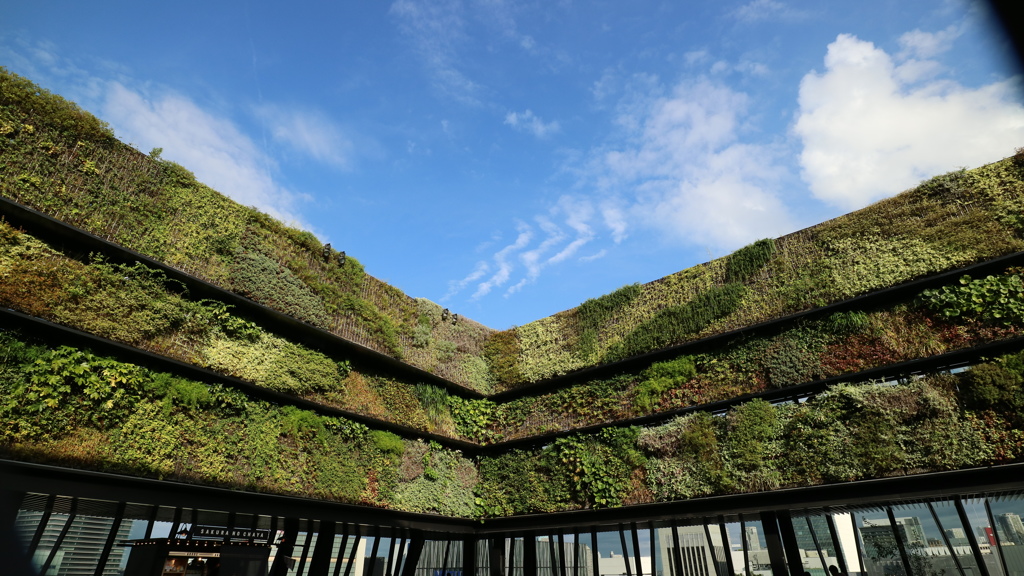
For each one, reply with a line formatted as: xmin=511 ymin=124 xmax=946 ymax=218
xmin=256 ymin=106 xmax=355 ymax=169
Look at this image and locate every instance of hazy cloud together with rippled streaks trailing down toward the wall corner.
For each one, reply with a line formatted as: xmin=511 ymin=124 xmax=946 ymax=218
xmin=446 ymin=75 xmax=794 ymax=299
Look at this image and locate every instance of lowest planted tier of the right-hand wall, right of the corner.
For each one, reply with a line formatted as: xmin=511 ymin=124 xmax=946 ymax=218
xmin=477 ymin=354 xmax=1024 ymax=516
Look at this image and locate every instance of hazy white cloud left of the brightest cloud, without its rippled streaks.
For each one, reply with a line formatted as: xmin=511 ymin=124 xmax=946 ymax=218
xmin=592 ymin=79 xmax=793 ymax=249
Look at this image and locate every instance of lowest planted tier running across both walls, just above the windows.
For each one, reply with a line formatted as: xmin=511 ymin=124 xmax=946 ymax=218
xmin=0 ymin=332 xmax=1024 ymax=517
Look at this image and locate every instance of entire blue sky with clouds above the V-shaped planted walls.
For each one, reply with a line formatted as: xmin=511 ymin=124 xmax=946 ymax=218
xmin=0 ymin=0 xmax=1024 ymax=328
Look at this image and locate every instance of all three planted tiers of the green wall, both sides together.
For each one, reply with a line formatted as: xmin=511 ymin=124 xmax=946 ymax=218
xmin=6 ymin=70 xmax=1024 ymax=518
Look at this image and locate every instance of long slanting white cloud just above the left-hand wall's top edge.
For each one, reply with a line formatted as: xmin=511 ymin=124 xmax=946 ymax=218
xmin=99 ymin=82 xmax=302 ymax=224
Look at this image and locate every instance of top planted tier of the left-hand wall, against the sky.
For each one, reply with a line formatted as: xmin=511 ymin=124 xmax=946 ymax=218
xmin=0 ymin=69 xmax=490 ymax=392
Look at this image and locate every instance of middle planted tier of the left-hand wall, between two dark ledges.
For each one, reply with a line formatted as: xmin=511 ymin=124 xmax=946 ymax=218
xmin=0 ymin=220 xmax=495 ymax=439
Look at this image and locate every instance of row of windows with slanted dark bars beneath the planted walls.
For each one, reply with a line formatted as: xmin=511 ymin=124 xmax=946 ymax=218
xmin=14 ymin=492 xmax=1024 ymax=576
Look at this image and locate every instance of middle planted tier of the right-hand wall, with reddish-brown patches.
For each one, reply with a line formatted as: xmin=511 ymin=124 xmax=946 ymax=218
xmin=467 ymin=268 xmax=1024 ymax=442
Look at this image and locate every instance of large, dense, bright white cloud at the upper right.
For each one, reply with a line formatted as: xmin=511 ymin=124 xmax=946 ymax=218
xmin=794 ymin=33 xmax=1024 ymax=209
